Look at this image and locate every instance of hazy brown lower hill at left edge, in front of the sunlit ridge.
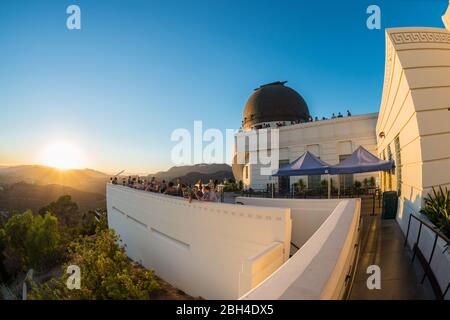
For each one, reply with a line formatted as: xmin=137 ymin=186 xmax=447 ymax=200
xmin=0 ymin=182 xmax=106 ymax=213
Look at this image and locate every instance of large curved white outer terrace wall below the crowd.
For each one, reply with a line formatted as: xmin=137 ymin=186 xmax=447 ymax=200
xmin=107 ymin=185 xmax=291 ymax=299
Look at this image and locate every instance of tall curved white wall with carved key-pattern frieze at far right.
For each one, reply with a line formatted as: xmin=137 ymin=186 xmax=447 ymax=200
xmin=376 ymin=28 xmax=450 ymax=299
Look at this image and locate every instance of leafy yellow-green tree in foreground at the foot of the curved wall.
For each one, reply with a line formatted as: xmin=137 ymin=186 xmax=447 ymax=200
xmin=30 ymin=230 xmax=158 ymax=299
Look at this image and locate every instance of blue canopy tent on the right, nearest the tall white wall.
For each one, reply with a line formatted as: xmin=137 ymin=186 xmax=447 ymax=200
xmin=329 ymin=146 xmax=395 ymax=174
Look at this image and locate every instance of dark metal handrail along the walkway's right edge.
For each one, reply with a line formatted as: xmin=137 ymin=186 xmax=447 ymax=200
xmin=403 ymin=212 xmax=450 ymax=299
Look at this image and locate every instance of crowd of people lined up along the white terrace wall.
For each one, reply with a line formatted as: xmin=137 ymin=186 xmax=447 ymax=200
xmin=110 ymin=176 xmax=219 ymax=203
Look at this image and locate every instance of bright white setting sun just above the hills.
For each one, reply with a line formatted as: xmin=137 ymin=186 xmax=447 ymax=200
xmin=42 ymin=142 xmax=84 ymax=170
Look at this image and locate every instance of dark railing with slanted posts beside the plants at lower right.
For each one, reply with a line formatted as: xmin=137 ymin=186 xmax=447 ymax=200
xmin=404 ymin=213 xmax=450 ymax=299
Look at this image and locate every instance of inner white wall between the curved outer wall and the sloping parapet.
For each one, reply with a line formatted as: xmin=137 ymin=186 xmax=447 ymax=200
xmin=236 ymin=197 xmax=340 ymax=251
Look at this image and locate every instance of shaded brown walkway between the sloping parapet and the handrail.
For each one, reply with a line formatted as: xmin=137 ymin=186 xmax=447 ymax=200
xmin=350 ymin=208 xmax=435 ymax=300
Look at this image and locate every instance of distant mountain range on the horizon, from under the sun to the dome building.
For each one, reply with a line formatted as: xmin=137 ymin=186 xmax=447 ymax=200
xmin=0 ymin=164 xmax=233 ymax=212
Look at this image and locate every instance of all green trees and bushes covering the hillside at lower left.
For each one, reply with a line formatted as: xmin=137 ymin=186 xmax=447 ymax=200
xmin=0 ymin=196 xmax=189 ymax=299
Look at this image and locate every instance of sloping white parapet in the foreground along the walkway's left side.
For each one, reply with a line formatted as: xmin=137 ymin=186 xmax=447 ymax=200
xmin=241 ymin=199 xmax=361 ymax=300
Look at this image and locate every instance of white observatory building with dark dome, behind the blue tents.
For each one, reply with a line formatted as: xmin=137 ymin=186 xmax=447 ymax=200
xmin=233 ymin=82 xmax=378 ymax=192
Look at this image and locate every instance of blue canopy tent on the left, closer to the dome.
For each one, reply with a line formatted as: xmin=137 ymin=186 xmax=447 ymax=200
xmin=273 ymin=151 xmax=330 ymax=177
